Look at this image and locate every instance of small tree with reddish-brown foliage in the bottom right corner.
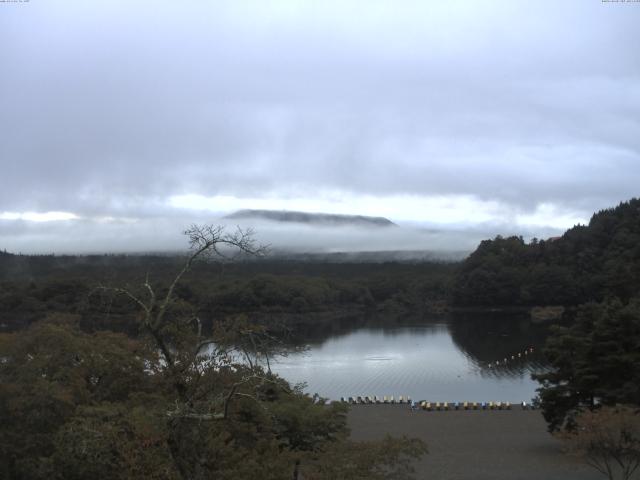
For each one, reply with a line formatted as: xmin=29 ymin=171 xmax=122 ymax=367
xmin=561 ymin=406 xmax=640 ymax=480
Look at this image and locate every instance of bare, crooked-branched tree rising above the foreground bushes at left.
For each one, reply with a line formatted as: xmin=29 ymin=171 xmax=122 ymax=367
xmin=94 ymin=225 xmax=284 ymax=479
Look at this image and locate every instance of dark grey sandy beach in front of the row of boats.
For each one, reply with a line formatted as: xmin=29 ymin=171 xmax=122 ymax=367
xmin=348 ymin=405 xmax=604 ymax=480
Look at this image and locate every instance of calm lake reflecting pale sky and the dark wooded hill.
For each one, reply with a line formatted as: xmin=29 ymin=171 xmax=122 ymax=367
xmin=272 ymin=315 xmax=546 ymax=403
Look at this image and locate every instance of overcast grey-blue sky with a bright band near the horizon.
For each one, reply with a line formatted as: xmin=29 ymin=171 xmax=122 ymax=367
xmin=0 ymin=0 xmax=640 ymax=252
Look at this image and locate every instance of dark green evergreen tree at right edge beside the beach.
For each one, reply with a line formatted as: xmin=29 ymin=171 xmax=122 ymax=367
xmin=534 ymin=299 xmax=640 ymax=431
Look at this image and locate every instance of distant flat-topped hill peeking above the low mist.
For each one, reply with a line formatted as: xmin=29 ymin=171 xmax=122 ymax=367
xmin=224 ymin=210 xmax=397 ymax=227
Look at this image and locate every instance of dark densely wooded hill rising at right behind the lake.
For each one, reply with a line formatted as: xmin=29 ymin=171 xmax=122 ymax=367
xmin=453 ymin=198 xmax=640 ymax=306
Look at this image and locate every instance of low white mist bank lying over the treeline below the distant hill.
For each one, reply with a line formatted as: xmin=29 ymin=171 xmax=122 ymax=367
xmin=0 ymin=215 xmax=563 ymax=257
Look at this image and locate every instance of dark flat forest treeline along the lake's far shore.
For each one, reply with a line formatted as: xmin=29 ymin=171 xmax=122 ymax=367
xmin=0 ymin=254 xmax=455 ymax=333
